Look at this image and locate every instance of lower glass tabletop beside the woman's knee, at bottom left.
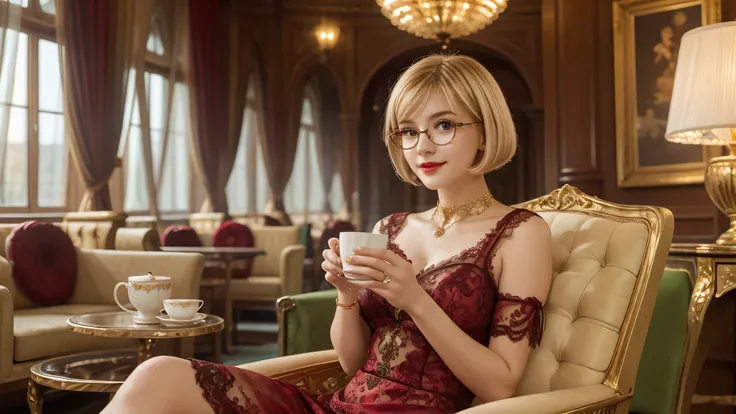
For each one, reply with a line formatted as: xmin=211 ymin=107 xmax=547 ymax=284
xmin=31 ymin=349 xmax=138 ymax=392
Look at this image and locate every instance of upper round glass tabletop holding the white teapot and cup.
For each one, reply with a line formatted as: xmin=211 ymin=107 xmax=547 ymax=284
xmin=67 ymin=311 xmax=224 ymax=339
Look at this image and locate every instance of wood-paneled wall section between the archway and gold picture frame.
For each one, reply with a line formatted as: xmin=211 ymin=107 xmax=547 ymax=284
xmin=542 ymin=0 xmax=736 ymax=242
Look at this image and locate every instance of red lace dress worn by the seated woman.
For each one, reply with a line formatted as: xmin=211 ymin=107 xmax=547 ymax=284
xmin=191 ymin=209 xmax=542 ymax=414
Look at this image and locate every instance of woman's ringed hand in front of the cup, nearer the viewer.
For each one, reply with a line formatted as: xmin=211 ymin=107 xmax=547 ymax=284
xmin=340 ymin=247 xmax=429 ymax=314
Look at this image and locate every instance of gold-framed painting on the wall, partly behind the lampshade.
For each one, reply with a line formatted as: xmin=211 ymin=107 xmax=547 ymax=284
xmin=613 ymin=0 xmax=723 ymax=187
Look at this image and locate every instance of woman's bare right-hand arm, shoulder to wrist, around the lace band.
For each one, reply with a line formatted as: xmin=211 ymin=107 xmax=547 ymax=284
xmin=406 ymin=217 xmax=552 ymax=402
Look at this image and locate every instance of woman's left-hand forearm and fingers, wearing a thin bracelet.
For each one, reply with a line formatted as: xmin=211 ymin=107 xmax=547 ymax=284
xmin=322 ymin=222 xmax=380 ymax=376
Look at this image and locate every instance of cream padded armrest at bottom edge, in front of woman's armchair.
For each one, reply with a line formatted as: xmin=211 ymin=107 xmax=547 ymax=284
xmin=461 ymin=384 xmax=631 ymax=414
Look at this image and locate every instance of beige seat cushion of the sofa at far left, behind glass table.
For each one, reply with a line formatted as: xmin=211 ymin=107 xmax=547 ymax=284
xmin=13 ymin=305 xmax=133 ymax=362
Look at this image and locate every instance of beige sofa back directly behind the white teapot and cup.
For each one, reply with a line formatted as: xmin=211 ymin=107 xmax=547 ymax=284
xmin=70 ymin=249 xmax=204 ymax=305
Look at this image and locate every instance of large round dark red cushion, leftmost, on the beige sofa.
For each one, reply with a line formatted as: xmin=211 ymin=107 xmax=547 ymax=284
xmin=5 ymin=221 xmax=77 ymax=306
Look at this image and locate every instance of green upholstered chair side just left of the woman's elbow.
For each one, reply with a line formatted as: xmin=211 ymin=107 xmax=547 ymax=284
xmin=276 ymin=289 xmax=337 ymax=356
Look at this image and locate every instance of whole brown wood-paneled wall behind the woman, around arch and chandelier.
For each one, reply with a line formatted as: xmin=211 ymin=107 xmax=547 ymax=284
xmin=236 ymin=0 xmax=736 ymax=242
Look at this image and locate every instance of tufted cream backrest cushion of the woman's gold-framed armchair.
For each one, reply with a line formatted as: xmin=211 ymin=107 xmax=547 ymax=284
xmin=517 ymin=212 xmax=649 ymax=395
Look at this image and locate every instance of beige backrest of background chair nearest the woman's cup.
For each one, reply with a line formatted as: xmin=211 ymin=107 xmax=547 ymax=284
xmin=251 ymin=226 xmax=299 ymax=277
